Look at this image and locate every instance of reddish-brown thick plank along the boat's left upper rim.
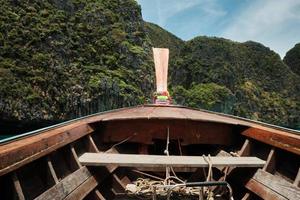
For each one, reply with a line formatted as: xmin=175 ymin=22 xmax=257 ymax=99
xmin=0 ymin=124 xmax=94 ymax=176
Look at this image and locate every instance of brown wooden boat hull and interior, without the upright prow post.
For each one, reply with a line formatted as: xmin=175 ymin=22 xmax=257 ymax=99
xmin=0 ymin=48 xmax=300 ymax=200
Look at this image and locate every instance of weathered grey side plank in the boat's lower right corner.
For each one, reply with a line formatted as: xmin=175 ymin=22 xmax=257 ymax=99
xmin=246 ymin=169 xmax=300 ymax=200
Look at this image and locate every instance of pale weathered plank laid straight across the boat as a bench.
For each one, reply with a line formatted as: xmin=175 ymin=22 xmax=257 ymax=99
xmin=79 ymin=153 xmax=265 ymax=167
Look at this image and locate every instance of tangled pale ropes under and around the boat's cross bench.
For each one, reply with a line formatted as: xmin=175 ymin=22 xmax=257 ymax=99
xmin=125 ymin=126 xmax=233 ymax=200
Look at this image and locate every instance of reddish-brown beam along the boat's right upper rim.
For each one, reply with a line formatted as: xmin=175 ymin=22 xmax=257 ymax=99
xmin=242 ymin=128 xmax=300 ymax=155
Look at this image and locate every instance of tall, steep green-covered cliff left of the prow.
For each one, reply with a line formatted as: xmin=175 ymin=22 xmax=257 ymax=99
xmin=0 ymin=0 xmax=153 ymax=120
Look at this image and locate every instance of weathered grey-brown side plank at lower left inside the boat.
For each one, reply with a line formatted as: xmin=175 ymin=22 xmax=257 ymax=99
xmin=36 ymin=167 xmax=92 ymax=200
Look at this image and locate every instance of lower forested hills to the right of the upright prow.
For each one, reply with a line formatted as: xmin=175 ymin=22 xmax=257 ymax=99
xmin=147 ymin=23 xmax=300 ymax=129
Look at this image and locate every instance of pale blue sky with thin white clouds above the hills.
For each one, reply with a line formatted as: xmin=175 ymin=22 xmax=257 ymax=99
xmin=137 ymin=0 xmax=300 ymax=58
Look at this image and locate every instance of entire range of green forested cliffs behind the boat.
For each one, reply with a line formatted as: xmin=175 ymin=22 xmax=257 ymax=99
xmin=0 ymin=0 xmax=300 ymax=129
